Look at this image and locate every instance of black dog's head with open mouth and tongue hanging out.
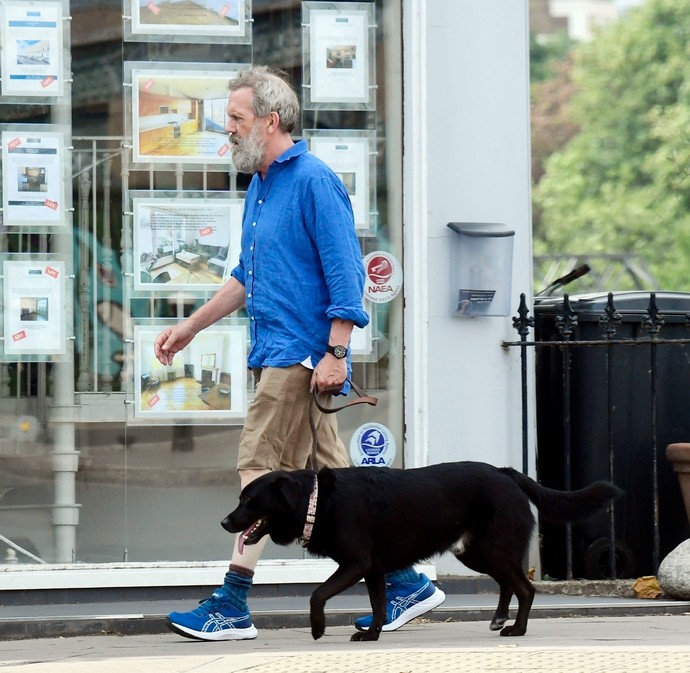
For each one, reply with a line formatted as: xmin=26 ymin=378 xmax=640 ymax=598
xmin=221 ymin=470 xmax=314 ymax=553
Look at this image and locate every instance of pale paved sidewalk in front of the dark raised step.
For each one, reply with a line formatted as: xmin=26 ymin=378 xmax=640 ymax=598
xmin=0 ymin=615 xmax=690 ymax=673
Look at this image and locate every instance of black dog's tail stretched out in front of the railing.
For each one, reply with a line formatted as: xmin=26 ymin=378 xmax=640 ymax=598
xmin=500 ymin=467 xmax=623 ymax=523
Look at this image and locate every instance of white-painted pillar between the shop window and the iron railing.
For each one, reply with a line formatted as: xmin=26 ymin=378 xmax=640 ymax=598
xmin=403 ymin=0 xmax=533 ymax=574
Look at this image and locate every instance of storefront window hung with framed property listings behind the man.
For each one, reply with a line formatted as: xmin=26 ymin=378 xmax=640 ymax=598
xmin=0 ymin=0 xmax=403 ymax=564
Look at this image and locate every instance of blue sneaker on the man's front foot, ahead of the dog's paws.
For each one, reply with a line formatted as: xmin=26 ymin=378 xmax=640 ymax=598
xmin=165 ymin=589 xmax=258 ymax=640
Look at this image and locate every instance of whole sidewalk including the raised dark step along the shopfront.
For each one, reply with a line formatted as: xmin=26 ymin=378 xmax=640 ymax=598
xmin=0 ymin=587 xmax=690 ymax=673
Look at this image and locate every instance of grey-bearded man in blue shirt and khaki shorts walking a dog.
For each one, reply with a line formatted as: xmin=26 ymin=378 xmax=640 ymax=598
xmin=154 ymin=66 xmax=445 ymax=640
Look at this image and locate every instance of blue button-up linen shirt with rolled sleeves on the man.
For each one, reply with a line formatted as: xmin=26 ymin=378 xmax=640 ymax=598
xmin=232 ymin=141 xmax=369 ymax=367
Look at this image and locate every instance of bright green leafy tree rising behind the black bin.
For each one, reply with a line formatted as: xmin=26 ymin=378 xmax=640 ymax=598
xmin=534 ymin=0 xmax=690 ymax=291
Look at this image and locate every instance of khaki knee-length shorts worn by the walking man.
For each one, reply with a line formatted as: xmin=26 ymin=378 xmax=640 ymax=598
xmin=237 ymin=364 xmax=350 ymax=470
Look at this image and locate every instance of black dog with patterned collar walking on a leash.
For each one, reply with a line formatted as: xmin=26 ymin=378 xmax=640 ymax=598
xmin=222 ymin=462 xmax=622 ymax=640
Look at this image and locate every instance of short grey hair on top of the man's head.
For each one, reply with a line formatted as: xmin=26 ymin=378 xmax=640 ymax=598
xmin=228 ymin=65 xmax=300 ymax=133
